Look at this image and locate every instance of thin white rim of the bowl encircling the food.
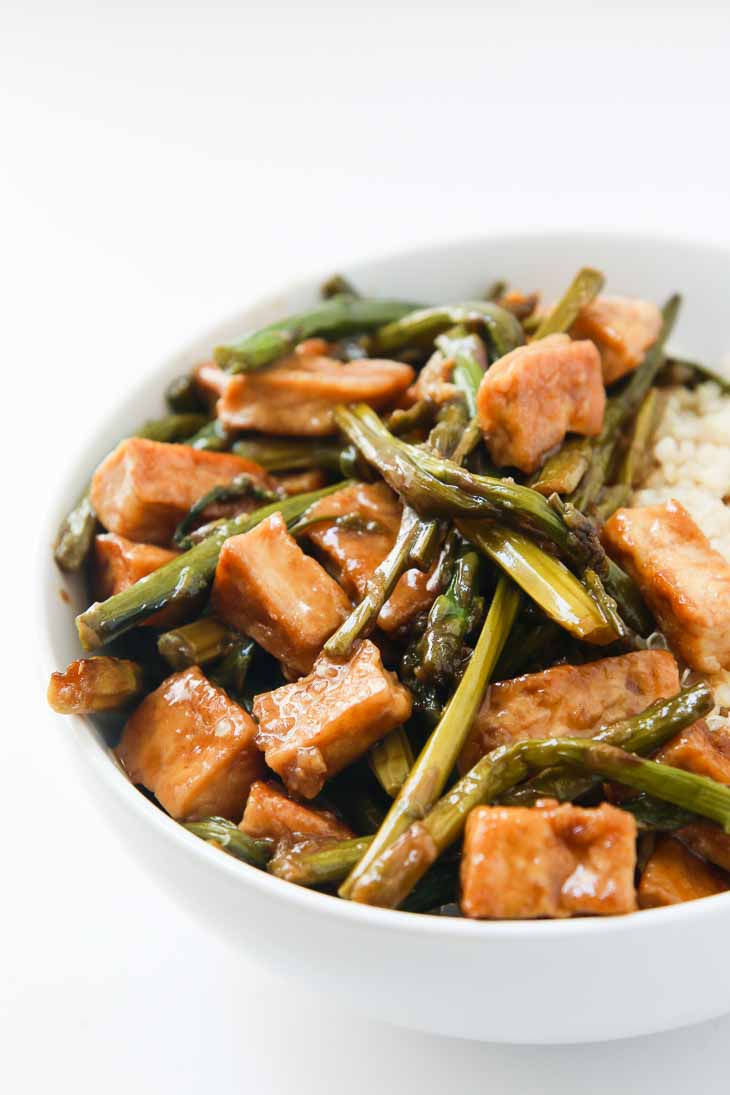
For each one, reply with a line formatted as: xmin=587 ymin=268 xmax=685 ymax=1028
xmin=41 ymin=227 xmax=730 ymax=942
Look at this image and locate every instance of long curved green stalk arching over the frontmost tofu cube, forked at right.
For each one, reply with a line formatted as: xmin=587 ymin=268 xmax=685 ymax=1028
xmin=352 ymin=693 xmax=713 ymax=908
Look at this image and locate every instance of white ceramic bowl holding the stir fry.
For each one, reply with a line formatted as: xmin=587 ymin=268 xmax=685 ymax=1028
xmin=42 ymin=232 xmax=730 ymax=1042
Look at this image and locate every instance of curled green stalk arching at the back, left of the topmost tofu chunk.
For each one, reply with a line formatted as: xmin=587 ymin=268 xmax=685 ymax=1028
xmin=370 ymin=300 xmax=524 ymax=357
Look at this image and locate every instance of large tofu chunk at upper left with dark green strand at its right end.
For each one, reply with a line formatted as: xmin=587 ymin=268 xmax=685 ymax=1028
xmin=91 ymin=437 xmax=271 ymax=546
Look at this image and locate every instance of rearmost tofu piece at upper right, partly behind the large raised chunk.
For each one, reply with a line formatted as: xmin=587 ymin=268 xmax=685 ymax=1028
xmin=571 ymin=297 xmax=662 ymax=384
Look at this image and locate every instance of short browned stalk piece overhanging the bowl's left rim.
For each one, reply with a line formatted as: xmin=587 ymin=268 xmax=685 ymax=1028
xmin=48 ymin=655 xmax=144 ymax=715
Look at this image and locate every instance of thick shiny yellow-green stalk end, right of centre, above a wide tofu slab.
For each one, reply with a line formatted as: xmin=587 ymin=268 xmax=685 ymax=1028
xmin=456 ymin=520 xmax=622 ymax=645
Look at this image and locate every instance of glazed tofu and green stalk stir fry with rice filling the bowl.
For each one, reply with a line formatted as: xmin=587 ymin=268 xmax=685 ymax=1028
xmin=48 ymin=267 xmax=730 ymax=920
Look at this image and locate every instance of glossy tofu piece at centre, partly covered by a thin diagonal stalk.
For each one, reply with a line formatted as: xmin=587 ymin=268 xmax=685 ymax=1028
xmin=308 ymin=483 xmax=436 ymax=634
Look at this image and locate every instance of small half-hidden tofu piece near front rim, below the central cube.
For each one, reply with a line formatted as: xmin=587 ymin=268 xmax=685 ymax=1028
xmin=239 ymin=780 xmax=355 ymax=841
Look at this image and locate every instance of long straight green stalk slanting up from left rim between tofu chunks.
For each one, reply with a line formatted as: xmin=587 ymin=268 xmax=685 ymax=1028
xmin=76 ymin=481 xmax=350 ymax=650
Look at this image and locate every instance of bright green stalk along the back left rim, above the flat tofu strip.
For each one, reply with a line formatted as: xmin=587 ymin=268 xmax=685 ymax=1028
xmin=216 ymin=293 xmax=418 ymax=372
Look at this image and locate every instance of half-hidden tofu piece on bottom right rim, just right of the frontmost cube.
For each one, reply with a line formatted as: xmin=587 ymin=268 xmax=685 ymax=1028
xmin=638 ymin=837 xmax=730 ymax=909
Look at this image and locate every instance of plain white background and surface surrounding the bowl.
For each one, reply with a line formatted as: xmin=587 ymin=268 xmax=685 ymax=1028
xmin=0 ymin=0 xmax=730 ymax=1095
